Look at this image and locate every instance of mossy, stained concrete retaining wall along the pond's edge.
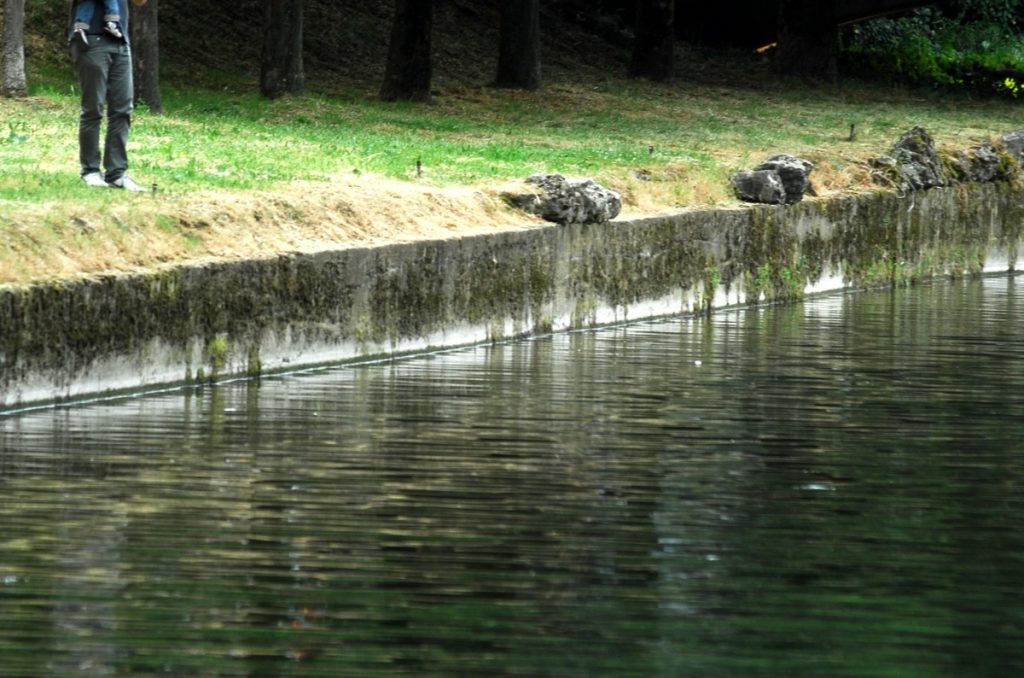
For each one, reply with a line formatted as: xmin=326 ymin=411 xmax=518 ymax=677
xmin=0 ymin=184 xmax=1024 ymax=412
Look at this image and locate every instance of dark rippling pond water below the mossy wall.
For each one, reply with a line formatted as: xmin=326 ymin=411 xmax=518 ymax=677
xmin=0 ymin=278 xmax=1024 ymax=676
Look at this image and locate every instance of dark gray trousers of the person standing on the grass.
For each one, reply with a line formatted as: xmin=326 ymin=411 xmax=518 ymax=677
xmin=71 ymin=35 xmax=134 ymax=181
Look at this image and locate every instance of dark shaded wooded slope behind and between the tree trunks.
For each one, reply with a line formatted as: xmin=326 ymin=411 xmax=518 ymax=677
xmin=14 ymin=0 xmax=1024 ymax=102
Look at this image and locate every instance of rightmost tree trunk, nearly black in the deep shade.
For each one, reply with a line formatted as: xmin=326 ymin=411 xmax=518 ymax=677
xmin=776 ymin=0 xmax=839 ymax=82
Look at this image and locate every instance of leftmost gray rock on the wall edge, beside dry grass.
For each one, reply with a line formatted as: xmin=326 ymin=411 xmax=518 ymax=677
xmin=505 ymin=174 xmax=623 ymax=224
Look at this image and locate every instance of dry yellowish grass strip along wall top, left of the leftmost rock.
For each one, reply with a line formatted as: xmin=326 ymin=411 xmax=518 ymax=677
xmin=0 ymin=175 xmax=540 ymax=284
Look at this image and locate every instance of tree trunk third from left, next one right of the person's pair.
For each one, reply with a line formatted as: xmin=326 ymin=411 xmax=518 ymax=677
xmin=259 ymin=0 xmax=306 ymax=99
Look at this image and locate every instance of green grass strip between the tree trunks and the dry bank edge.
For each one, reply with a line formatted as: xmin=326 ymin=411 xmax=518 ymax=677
xmin=0 ymin=53 xmax=1022 ymax=284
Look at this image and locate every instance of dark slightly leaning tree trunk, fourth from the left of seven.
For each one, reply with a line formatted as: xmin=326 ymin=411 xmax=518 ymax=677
xmin=381 ymin=0 xmax=434 ymax=101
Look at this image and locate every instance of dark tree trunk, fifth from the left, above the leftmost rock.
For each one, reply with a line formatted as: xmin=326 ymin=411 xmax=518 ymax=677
xmin=495 ymin=0 xmax=541 ymax=89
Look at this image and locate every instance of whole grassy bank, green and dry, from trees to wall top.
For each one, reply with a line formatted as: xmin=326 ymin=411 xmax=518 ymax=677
xmin=0 ymin=47 xmax=1022 ymax=283
